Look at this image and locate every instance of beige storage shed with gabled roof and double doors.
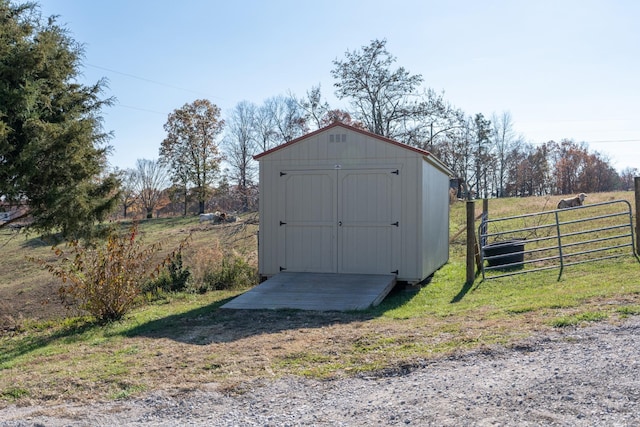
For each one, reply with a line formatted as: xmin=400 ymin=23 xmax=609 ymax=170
xmin=255 ymin=123 xmax=452 ymax=283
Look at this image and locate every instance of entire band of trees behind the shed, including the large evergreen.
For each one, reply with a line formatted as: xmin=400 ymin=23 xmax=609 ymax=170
xmin=0 ymin=0 xmax=638 ymax=239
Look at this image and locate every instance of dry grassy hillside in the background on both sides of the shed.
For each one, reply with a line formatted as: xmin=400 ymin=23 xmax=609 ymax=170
xmin=0 ymin=192 xmax=635 ymax=321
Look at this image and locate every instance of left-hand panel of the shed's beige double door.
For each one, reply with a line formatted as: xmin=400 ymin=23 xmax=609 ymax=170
xmin=279 ymin=170 xmax=337 ymax=273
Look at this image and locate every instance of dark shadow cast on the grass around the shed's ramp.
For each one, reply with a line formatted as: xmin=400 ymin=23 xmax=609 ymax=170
xmin=122 ymin=289 xmax=415 ymax=345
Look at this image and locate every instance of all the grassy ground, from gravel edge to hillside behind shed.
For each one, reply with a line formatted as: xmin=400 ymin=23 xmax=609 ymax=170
xmin=0 ymin=192 xmax=640 ymax=407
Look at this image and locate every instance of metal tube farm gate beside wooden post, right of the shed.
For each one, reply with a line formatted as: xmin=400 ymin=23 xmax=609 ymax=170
xmin=478 ymin=200 xmax=640 ymax=280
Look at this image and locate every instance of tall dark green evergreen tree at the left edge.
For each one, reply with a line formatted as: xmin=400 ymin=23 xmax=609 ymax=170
xmin=0 ymin=0 xmax=118 ymax=238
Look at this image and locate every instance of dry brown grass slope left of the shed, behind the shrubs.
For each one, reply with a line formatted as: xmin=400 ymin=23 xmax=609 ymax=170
xmin=0 ymin=215 xmax=257 ymax=331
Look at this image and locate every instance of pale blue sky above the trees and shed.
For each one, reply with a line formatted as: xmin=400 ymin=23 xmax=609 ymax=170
xmin=40 ymin=0 xmax=640 ymax=174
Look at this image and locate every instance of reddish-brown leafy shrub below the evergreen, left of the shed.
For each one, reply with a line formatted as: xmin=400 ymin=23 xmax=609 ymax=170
xmin=35 ymin=224 xmax=187 ymax=322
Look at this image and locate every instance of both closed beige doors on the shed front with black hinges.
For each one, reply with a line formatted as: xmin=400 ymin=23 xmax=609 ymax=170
xmin=279 ymin=168 xmax=400 ymax=274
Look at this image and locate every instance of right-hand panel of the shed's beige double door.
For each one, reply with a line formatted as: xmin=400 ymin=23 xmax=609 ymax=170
xmin=338 ymin=169 xmax=400 ymax=274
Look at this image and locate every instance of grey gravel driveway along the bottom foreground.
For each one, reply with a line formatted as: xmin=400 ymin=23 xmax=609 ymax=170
xmin=0 ymin=317 xmax=640 ymax=426
